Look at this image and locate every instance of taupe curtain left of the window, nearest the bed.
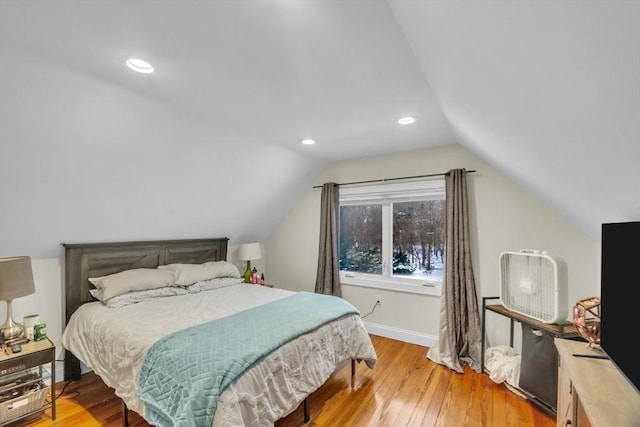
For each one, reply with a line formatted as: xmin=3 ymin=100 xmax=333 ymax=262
xmin=315 ymin=182 xmax=342 ymax=297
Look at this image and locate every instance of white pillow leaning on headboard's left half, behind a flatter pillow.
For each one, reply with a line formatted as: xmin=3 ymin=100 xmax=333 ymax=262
xmin=89 ymin=268 xmax=176 ymax=300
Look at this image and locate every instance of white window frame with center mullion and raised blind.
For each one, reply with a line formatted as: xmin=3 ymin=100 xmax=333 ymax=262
xmin=339 ymin=179 xmax=446 ymax=297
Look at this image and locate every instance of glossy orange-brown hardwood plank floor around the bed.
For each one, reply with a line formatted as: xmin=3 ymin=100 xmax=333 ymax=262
xmin=17 ymin=335 xmax=556 ymax=427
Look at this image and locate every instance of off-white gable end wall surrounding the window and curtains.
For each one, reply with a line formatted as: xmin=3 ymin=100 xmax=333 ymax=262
xmin=266 ymin=145 xmax=600 ymax=352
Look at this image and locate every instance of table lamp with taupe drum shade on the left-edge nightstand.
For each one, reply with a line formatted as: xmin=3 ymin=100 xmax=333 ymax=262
xmin=0 ymin=256 xmax=36 ymax=340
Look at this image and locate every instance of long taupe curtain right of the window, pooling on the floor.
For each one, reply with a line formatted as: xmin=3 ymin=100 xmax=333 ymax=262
xmin=427 ymin=169 xmax=482 ymax=373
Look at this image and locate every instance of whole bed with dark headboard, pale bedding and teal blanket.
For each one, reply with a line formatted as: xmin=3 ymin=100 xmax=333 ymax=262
xmin=62 ymin=238 xmax=377 ymax=427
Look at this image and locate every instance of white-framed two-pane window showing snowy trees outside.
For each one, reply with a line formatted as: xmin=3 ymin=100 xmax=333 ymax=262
xmin=339 ymin=179 xmax=445 ymax=296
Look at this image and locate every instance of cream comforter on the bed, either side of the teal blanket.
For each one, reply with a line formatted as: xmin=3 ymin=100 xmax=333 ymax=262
xmin=62 ymin=283 xmax=376 ymax=427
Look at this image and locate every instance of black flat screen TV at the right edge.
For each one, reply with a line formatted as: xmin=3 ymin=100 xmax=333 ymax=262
xmin=600 ymin=221 xmax=640 ymax=392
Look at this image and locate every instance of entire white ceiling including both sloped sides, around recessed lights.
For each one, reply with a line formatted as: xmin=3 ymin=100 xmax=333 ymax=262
xmin=0 ymin=0 xmax=640 ymax=256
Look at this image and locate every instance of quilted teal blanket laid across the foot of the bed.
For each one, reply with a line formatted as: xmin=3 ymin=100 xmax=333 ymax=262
xmin=138 ymin=292 xmax=359 ymax=427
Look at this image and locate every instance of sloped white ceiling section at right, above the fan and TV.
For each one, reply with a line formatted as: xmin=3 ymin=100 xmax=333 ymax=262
xmin=390 ymin=0 xmax=640 ymax=240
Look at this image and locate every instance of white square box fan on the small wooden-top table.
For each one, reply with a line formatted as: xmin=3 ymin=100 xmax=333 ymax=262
xmin=500 ymin=249 xmax=568 ymax=323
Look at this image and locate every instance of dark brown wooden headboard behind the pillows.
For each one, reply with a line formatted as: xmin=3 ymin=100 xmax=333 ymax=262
xmin=62 ymin=237 xmax=229 ymax=381
